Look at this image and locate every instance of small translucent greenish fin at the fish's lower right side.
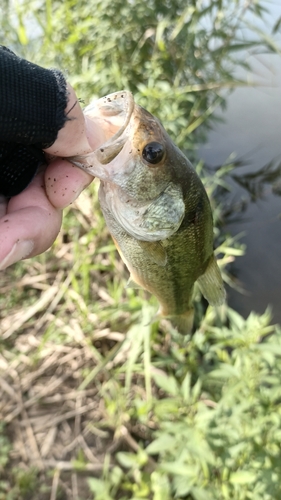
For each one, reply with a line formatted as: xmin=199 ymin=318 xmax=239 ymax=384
xmin=197 ymin=255 xmax=225 ymax=306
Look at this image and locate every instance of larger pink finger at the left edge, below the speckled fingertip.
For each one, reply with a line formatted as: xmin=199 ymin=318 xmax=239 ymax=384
xmin=0 ymin=174 xmax=62 ymax=270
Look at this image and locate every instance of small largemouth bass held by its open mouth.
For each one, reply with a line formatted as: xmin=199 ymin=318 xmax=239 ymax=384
xmin=70 ymin=91 xmax=225 ymax=333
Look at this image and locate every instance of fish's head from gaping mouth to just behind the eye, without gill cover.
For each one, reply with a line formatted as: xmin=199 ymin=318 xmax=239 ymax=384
xmin=69 ymin=91 xmax=179 ymax=195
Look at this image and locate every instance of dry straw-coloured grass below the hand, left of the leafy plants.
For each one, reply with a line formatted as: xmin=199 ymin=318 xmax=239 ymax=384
xmin=0 ymin=187 xmax=151 ymax=500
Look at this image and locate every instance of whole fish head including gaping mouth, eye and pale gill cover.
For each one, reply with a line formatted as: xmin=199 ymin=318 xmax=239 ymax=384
xmin=69 ymin=91 xmax=188 ymax=241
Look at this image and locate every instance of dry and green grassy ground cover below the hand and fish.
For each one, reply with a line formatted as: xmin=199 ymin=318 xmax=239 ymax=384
xmin=0 ymin=174 xmax=281 ymax=500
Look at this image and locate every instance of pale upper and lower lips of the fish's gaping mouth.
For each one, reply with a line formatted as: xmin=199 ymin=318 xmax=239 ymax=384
xmin=66 ymin=90 xmax=135 ymax=180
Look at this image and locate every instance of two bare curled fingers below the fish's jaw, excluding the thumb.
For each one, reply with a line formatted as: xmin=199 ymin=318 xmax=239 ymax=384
xmin=0 ymin=159 xmax=93 ymax=270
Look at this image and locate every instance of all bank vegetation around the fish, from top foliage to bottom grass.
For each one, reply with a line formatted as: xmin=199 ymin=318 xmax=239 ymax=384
xmin=0 ymin=0 xmax=281 ymax=500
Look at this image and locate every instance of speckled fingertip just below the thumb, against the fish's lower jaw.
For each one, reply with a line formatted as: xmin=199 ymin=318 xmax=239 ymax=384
xmin=45 ymin=159 xmax=94 ymax=208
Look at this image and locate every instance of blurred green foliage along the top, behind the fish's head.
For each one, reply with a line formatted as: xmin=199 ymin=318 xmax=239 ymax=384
xmin=0 ymin=0 xmax=268 ymax=155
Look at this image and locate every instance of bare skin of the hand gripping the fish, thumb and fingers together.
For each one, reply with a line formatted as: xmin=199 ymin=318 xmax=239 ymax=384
xmin=0 ymin=86 xmax=105 ymax=270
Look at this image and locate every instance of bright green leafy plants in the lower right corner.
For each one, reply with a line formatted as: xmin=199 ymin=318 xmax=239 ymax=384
xmin=89 ymin=309 xmax=281 ymax=500
